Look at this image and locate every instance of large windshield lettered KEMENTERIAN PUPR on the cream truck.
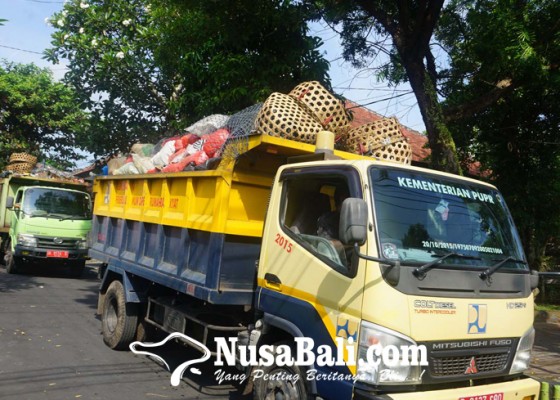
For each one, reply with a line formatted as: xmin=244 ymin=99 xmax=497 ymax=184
xmin=370 ymin=168 xmax=527 ymax=270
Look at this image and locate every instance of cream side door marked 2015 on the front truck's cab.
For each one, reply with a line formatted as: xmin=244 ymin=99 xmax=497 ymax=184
xmin=258 ymin=164 xmax=365 ymax=398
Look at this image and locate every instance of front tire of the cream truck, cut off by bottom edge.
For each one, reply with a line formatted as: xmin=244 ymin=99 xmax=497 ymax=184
xmin=251 ymin=343 xmax=310 ymax=400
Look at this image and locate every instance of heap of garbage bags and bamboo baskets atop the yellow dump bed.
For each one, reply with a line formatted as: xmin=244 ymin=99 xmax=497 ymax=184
xmin=107 ymin=81 xmax=412 ymax=175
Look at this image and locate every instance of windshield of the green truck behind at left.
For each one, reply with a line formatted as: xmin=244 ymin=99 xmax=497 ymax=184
xmin=22 ymin=188 xmax=91 ymax=219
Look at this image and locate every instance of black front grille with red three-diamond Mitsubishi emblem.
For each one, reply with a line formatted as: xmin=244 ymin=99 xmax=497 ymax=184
xmin=430 ymin=353 xmax=509 ymax=376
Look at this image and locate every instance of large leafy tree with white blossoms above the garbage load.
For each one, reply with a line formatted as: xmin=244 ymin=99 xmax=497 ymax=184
xmin=46 ymin=0 xmax=329 ymax=155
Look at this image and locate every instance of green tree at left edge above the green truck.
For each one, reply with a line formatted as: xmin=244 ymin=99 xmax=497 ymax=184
xmin=0 ymin=61 xmax=88 ymax=166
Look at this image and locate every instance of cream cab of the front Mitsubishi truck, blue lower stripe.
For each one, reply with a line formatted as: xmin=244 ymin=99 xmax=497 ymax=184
xmin=257 ymin=161 xmax=538 ymax=399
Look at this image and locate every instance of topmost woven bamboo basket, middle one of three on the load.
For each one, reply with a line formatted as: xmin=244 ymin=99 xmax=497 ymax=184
xmin=289 ymin=81 xmax=350 ymax=136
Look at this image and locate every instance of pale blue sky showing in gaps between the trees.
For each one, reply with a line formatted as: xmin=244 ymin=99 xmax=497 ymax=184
xmin=0 ymin=0 xmax=425 ymax=132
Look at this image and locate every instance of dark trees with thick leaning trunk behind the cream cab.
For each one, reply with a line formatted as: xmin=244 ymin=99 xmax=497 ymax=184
xmin=314 ymin=0 xmax=560 ymax=267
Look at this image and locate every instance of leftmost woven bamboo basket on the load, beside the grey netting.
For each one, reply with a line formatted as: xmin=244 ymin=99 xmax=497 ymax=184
xmin=255 ymin=92 xmax=324 ymax=144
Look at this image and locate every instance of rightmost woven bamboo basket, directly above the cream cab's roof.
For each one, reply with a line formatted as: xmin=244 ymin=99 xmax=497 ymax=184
xmin=344 ymin=118 xmax=412 ymax=165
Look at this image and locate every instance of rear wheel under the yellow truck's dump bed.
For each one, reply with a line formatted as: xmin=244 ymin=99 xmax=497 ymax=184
xmin=101 ymin=281 xmax=138 ymax=350
